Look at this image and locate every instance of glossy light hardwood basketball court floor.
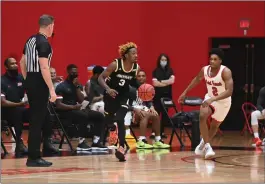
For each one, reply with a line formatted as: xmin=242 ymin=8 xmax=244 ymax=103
xmin=1 ymin=129 xmax=265 ymax=183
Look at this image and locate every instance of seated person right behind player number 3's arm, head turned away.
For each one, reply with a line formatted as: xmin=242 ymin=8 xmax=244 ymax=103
xmin=85 ymin=65 xmax=104 ymax=114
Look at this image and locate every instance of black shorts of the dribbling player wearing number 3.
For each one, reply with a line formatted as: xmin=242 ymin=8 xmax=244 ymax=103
xmin=103 ymin=93 xmax=129 ymax=114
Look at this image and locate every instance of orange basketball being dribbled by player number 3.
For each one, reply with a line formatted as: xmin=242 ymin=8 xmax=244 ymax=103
xmin=138 ymin=84 xmax=155 ymax=102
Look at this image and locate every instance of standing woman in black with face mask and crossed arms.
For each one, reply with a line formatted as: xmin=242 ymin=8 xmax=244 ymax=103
xmin=151 ymin=54 xmax=175 ymax=138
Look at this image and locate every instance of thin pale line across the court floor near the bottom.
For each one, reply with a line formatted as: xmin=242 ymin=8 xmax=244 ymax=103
xmin=1 ymin=167 xmax=194 ymax=180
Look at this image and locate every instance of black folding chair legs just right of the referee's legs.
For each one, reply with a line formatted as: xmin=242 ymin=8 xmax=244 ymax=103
xmin=47 ymin=102 xmax=74 ymax=152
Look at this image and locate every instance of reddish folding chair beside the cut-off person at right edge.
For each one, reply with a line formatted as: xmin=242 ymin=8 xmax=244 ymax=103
xmin=241 ymin=102 xmax=257 ymax=135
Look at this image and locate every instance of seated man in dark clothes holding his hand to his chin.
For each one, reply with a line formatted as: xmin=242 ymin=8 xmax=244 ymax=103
xmin=56 ymin=64 xmax=107 ymax=151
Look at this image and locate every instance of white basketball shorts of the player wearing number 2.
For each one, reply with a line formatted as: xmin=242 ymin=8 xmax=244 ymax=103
xmin=204 ymin=94 xmax=231 ymax=123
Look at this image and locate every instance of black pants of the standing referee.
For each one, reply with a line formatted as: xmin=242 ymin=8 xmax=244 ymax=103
xmin=25 ymin=73 xmax=52 ymax=159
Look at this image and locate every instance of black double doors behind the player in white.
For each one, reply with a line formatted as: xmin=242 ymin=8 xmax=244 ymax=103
xmin=211 ymin=38 xmax=265 ymax=130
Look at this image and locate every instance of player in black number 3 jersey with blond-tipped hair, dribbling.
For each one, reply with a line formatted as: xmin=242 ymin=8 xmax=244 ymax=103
xmin=98 ymin=42 xmax=140 ymax=161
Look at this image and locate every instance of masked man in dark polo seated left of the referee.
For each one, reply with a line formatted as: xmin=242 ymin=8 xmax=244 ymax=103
xmin=1 ymin=58 xmax=58 ymax=157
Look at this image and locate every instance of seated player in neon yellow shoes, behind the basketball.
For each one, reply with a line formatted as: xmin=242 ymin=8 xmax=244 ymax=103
xmin=125 ymin=70 xmax=170 ymax=149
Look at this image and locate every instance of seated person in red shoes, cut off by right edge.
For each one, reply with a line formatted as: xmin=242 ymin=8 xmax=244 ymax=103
xmin=251 ymin=86 xmax=265 ymax=146
